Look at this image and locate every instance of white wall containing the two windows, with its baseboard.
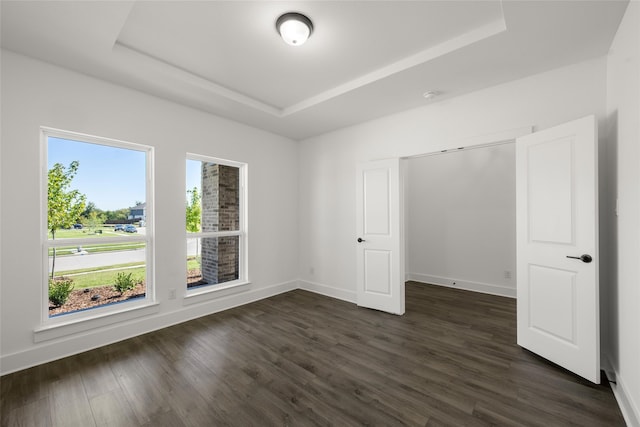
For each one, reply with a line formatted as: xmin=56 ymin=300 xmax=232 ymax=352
xmin=0 ymin=51 xmax=298 ymax=373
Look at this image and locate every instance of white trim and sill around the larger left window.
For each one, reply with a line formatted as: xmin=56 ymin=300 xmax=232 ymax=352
xmin=41 ymin=126 xmax=158 ymax=332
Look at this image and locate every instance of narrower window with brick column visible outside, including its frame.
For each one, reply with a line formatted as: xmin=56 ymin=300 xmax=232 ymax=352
xmin=186 ymin=154 xmax=247 ymax=294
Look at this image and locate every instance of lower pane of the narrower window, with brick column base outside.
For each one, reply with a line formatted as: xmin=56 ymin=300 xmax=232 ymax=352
xmin=187 ymin=236 xmax=240 ymax=288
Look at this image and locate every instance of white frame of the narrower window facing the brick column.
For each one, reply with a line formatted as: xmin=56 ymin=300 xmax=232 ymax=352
xmin=183 ymin=153 xmax=250 ymax=298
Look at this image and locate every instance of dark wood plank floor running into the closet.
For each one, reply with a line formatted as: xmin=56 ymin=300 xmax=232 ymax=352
xmin=1 ymin=283 xmax=624 ymax=427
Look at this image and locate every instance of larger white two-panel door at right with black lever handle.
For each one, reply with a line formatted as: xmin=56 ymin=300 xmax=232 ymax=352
xmin=516 ymin=116 xmax=600 ymax=384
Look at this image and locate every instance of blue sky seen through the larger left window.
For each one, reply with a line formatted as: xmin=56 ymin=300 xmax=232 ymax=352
xmin=47 ymin=137 xmax=146 ymax=211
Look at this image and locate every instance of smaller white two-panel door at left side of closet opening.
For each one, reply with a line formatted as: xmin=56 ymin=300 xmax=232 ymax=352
xmin=354 ymin=159 xmax=404 ymax=314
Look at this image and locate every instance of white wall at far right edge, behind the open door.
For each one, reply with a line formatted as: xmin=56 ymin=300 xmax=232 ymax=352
xmin=605 ymin=1 xmax=640 ymax=426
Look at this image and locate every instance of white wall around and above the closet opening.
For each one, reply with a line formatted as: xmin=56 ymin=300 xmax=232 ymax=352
xmin=299 ymin=58 xmax=606 ymax=301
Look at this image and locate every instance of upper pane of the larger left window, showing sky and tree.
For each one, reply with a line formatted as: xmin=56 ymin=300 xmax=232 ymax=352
xmin=47 ymin=136 xmax=147 ymax=240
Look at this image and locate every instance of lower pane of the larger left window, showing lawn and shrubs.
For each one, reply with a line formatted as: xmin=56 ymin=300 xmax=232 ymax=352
xmin=49 ymin=242 xmax=147 ymax=317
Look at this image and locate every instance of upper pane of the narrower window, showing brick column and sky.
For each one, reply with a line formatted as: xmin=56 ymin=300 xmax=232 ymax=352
xmin=186 ymin=160 xmax=240 ymax=233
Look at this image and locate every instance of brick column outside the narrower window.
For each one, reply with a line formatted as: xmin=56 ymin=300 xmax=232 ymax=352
xmin=201 ymin=162 xmax=240 ymax=284
